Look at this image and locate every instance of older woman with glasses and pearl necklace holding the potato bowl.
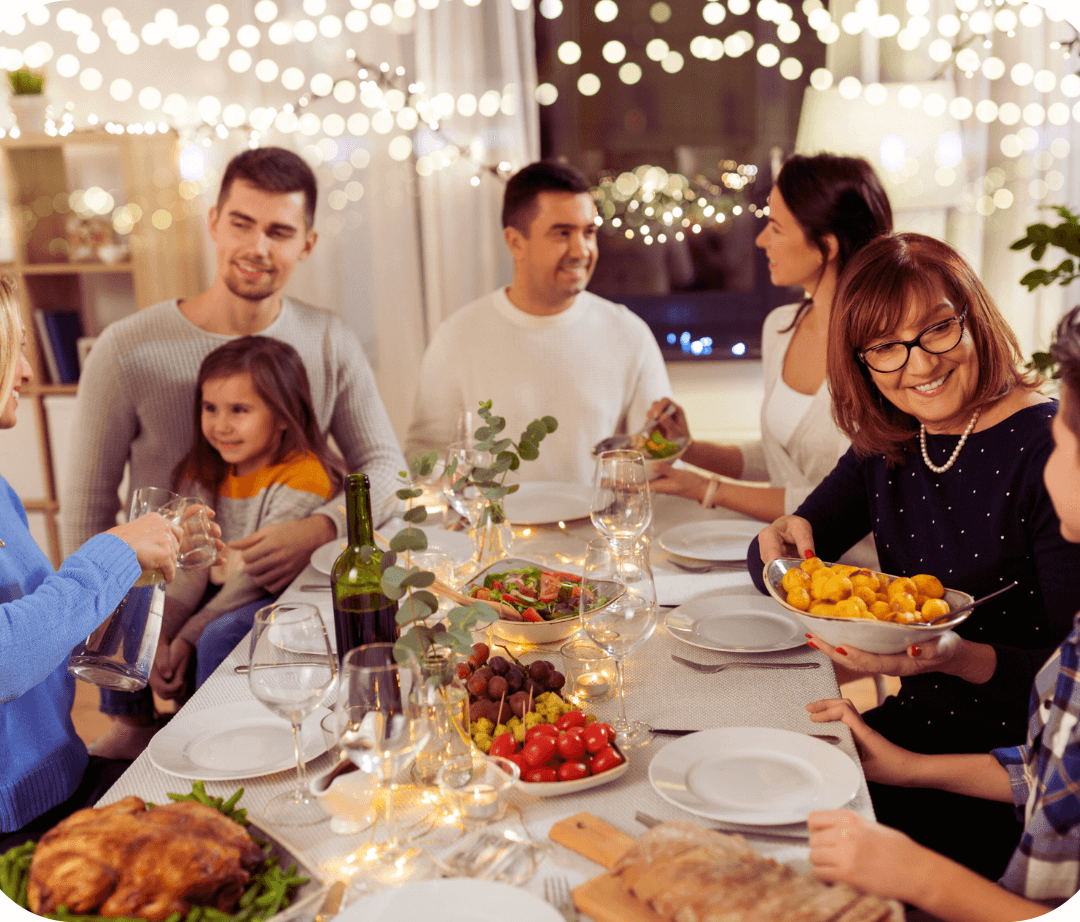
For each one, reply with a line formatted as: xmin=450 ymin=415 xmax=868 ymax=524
xmin=748 ymin=234 xmax=1080 ymax=880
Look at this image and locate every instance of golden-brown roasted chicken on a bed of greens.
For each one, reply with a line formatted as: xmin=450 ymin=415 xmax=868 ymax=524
xmin=27 ymin=797 xmax=265 ymax=922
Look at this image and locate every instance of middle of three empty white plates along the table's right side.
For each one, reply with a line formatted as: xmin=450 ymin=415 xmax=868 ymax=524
xmin=664 ymin=589 xmax=806 ymax=653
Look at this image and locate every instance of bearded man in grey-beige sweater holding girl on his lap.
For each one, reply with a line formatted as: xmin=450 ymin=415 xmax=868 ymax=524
xmin=63 ymin=148 xmax=404 ymax=593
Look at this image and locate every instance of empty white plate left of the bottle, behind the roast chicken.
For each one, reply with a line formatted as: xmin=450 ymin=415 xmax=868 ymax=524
xmin=147 ymin=701 xmax=327 ymax=782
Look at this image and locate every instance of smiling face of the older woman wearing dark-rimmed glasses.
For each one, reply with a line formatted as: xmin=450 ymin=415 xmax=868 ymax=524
xmin=863 ymin=287 xmax=978 ymax=433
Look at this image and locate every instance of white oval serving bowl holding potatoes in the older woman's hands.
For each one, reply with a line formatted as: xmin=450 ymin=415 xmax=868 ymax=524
xmin=765 ymin=557 xmax=973 ymax=653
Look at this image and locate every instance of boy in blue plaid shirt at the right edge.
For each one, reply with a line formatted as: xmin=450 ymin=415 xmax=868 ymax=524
xmin=807 ymin=308 xmax=1080 ymax=922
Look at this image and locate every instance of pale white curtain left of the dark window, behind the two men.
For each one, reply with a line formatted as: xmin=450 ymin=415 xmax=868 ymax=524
xmin=0 ymin=0 xmax=539 ymax=437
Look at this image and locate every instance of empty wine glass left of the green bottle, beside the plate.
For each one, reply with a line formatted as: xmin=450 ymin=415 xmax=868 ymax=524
xmin=247 ymin=602 xmax=337 ymax=826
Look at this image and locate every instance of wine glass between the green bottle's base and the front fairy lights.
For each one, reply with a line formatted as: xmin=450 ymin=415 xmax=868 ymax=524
xmin=335 ymin=643 xmax=431 ymax=879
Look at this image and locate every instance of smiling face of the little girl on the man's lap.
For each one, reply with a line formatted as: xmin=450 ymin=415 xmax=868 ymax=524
xmin=202 ymin=372 xmax=285 ymax=477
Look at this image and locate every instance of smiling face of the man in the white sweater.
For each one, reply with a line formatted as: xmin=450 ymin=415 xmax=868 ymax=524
xmin=504 ymin=192 xmax=597 ymax=314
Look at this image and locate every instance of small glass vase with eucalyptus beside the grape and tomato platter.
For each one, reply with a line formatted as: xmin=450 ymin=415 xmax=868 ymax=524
xmin=413 ymin=647 xmax=472 ymax=785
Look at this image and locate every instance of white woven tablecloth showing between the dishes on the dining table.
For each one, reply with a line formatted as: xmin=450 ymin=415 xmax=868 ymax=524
xmin=103 ymin=494 xmax=874 ymax=919
